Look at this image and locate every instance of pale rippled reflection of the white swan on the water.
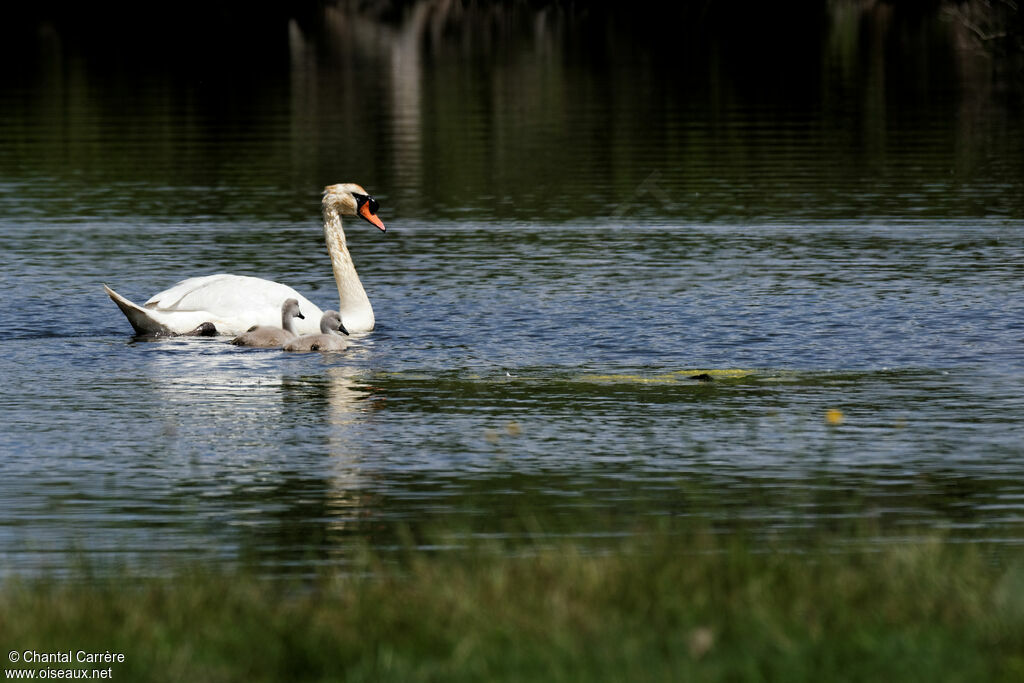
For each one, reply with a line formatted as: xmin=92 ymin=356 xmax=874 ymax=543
xmin=134 ymin=338 xmax=377 ymax=564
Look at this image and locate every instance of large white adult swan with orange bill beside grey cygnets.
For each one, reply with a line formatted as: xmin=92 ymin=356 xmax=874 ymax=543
xmin=103 ymin=183 xmax=386 ymax=336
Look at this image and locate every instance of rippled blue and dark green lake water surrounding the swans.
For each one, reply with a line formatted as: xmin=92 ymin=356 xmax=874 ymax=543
xmin=0 ymin=3 xmax=1024 ymax=573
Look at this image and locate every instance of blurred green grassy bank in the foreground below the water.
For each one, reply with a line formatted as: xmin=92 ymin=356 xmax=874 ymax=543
xmin=0 ymin=535 xmax=1024 ymax=681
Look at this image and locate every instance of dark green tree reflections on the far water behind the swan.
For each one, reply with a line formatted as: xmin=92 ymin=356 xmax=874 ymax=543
xmin=0 ymin=0 xmax=1024 ymax=221
